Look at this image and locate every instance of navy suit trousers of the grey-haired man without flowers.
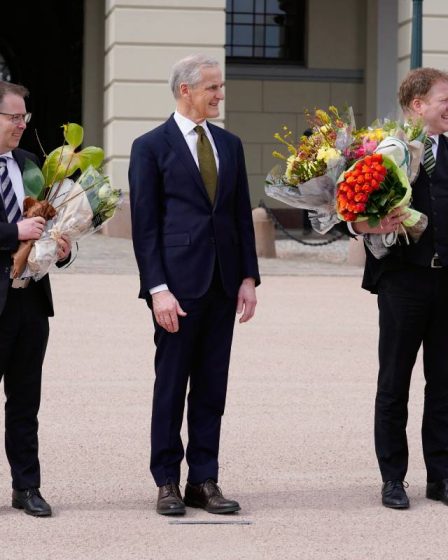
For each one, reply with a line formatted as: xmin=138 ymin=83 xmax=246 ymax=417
xmin=151 ymin=273 xmax=236 ymax=486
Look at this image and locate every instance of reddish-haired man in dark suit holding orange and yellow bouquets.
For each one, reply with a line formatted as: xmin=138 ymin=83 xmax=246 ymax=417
xmin=353 ymin=68 xmax=448 ymax=509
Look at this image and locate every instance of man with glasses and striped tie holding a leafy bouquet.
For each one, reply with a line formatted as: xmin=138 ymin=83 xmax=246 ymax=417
xmin=0 ymin=82 xmax=70 ymax=517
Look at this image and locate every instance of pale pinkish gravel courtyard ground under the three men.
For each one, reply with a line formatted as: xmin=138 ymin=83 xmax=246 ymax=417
xmin=0 ymin=235 xmax=448 ymax=560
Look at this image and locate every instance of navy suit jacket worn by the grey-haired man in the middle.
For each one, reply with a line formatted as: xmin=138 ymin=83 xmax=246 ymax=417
xmin=129 ymin=112 xmax=260 ymax=300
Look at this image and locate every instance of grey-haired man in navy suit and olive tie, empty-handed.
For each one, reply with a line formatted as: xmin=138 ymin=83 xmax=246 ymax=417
xmin=129 ymin=55 xmax=260 ymax=515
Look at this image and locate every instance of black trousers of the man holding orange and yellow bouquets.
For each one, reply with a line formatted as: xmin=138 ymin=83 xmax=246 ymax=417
xmin=375 ymin=265 xmax=448 ymax=482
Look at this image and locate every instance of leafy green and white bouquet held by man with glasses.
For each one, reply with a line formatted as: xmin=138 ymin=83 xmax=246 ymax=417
xmin=13 ymin=123 xmax=122 ymax=280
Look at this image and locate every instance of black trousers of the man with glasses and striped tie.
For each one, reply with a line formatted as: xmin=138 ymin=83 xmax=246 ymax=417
xmin=0 ymin=281 xmax=49 ymax=490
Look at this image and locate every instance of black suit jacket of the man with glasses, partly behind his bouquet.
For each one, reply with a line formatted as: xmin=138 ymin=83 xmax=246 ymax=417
xmin=0 ymin=148 xmax=54 ymax=317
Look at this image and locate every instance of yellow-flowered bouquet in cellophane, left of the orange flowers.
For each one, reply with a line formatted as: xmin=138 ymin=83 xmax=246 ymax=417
xmin=265 ymin=107 xmax=354 ymax=234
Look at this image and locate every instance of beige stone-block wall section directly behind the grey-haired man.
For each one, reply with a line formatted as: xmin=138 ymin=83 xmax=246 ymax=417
xmin=104 ymin=0 xmax=226 ymax=235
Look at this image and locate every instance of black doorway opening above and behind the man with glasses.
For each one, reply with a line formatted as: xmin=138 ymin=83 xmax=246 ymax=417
xmin=0 ymin=0 xmax=84 ymax=159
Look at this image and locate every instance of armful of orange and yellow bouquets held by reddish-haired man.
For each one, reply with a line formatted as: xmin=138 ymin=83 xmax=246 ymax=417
xmin=265 ymin=107 xmax=428 ymax=258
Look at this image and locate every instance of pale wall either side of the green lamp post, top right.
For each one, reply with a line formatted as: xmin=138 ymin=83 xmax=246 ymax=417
xmin=398 ymin=0 xmax=448 ymax=83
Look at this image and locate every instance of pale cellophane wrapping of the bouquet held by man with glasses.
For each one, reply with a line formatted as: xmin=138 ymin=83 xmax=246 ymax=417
xmin=24 ymin=166 xmax=122 ymax=281
